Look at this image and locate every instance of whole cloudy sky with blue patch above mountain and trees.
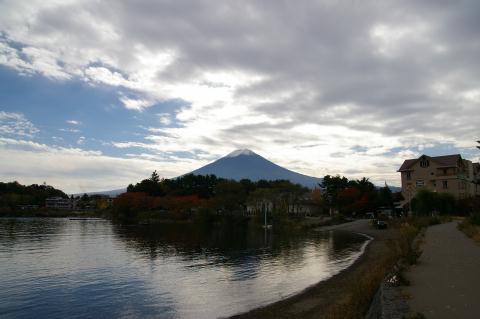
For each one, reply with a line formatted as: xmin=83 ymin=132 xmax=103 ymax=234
xmin=0 ymin=0 xmax=480 ymax=192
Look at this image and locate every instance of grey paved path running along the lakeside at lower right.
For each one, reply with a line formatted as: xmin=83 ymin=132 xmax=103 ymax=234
xmin=405 ymin=222 xmax=480 ymax=319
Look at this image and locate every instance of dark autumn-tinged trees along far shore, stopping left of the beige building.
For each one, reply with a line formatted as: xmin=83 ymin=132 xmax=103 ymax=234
xmin=0 ymin=171 xmax=394 ymax=228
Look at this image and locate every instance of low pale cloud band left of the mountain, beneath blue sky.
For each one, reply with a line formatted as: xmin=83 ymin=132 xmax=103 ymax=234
xmin=0 ymin=138 xmax=196 ymax=193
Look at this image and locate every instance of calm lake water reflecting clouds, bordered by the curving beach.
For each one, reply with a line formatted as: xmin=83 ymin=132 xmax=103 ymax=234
xmin=0 ymin=218 xmax=366 ymax=318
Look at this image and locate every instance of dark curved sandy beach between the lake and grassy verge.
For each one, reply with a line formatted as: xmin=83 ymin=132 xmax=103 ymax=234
xmin=231 ymin=220 xmax=395 ymax=318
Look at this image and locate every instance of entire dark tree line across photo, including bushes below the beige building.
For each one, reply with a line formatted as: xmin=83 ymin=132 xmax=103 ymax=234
xmin=0 ymin=171 xmax=479 ymax=222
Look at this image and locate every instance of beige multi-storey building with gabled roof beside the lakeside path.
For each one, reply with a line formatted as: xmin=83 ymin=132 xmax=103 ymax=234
xmin=398 ymin=154 xmax=480 ymax=202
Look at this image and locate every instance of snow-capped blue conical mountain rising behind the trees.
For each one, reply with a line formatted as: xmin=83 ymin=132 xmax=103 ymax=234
xmin=191 ymin=149 xmax=322 ymax=188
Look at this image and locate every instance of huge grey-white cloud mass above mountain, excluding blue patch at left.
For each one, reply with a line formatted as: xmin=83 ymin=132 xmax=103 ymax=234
xmin=0 ymin=0 xmax=480 ymax=189
